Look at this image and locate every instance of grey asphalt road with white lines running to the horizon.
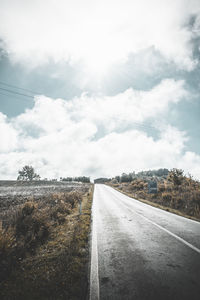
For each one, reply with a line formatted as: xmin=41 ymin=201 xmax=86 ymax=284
xmin=90 ymin=184 xmax=200 ymax=300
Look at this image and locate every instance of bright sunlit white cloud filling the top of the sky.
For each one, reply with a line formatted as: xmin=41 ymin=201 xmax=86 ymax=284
xmin=0 ymin=0 xmax=200 ymax=74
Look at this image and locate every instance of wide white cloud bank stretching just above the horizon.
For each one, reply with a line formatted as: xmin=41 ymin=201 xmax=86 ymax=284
xmin=0 ymin=79 xmax=200 ymax=179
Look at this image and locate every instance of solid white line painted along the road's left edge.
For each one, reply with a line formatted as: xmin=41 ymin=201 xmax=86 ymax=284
xmin=90 ymin=189 xmax=99 ymax=300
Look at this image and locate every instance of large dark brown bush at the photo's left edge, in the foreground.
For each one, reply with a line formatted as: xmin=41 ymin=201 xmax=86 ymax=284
xmin=0 ymin=202 xmax=49 ymax=280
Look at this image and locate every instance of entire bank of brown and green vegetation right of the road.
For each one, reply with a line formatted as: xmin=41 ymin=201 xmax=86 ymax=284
xmin=104 ymin=169 xmax=200 ymax=220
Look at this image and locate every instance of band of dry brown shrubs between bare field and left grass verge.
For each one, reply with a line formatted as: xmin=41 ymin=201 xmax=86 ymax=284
xmin=0 ymin=189 xmax=88 ymax=290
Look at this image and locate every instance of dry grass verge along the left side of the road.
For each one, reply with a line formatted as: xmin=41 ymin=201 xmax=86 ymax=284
xmin=0 ymin=187 xmax=93 ymax=300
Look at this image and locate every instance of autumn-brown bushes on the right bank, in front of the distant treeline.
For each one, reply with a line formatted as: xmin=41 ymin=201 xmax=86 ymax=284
xmin=111 ymin=169 xmax=200 ymax=219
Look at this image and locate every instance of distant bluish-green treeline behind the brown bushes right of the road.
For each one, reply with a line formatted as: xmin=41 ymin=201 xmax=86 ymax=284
xmin=94 ymin=169 xmax=169 ymax=183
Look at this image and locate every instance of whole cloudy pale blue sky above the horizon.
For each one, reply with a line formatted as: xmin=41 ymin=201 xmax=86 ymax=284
xmin=0 ymin=0 xmax=200 ymax=180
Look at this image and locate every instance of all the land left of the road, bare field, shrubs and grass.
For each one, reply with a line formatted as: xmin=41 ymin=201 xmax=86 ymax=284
xmin=0 ymin=181 xmax=92 ymax=300
